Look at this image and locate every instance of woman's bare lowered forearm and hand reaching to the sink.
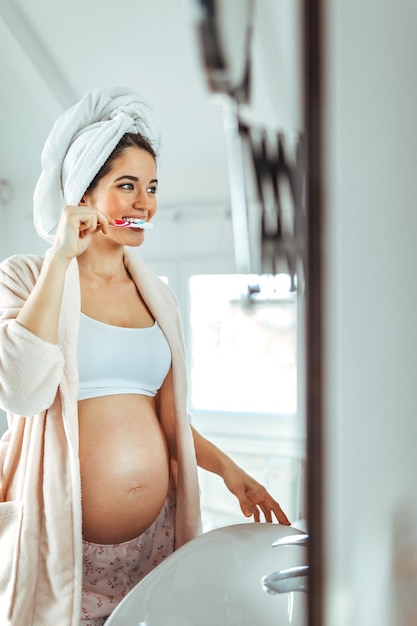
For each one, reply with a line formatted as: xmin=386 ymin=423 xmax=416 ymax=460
xmin=191 ymin=427 xmax=291 ymax=526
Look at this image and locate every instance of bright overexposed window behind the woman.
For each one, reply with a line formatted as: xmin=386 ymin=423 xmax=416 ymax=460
xmin=190 ymin=274 xmax=297 ymax=414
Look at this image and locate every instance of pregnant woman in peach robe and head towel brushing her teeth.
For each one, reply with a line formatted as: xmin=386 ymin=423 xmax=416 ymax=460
xmin=0 ymin=88 xmax=289 ymax=626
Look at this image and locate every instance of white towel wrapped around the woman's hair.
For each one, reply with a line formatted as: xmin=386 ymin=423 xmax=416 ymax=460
xmin=33 ymin=87 xmax=160 ymax=243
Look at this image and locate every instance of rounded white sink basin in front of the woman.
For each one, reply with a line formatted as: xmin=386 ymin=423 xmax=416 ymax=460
xmin=106 ymin=523 xmax=307 ymax=626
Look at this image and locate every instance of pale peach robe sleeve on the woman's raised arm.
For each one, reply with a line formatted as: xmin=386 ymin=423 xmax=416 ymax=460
xmin=0 ymin=256 xmax=64 ymax=416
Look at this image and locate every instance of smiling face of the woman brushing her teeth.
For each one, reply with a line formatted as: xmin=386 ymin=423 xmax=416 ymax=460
xmin=83 ymin=147 xmax=158 ymax=245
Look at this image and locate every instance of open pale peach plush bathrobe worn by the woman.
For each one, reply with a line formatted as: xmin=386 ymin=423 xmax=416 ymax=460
xmin=0 ymin=250 xmax=201 ymax=626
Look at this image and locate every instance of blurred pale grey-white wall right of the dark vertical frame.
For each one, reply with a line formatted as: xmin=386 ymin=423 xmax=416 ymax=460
xmin=324 ymin=0 xmax=417 ymax=626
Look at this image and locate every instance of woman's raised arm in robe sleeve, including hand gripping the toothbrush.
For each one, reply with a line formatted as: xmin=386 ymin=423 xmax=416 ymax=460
xmin=0 ymin=202 xmax=112 ymax=415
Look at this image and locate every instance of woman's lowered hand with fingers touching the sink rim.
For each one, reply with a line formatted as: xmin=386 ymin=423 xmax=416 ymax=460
xmin=223 ymin=463 xmax=291 ymax=526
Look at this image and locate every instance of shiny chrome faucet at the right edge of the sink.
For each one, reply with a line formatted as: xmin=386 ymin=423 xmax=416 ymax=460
xmin=262 ymin=533 xmax=309 ymax=594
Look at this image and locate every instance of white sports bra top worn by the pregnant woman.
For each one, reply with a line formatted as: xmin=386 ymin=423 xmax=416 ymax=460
xmin=77 ymin=313 xmax=171 ymax=400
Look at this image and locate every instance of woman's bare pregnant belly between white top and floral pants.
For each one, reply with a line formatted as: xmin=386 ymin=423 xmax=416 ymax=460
xmin=78 ymin=395 xmax=169 ymax=544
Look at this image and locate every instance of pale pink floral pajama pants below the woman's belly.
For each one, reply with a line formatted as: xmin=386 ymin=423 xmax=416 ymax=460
xmin=80 ymin=493 xmax=175 ymax=626
